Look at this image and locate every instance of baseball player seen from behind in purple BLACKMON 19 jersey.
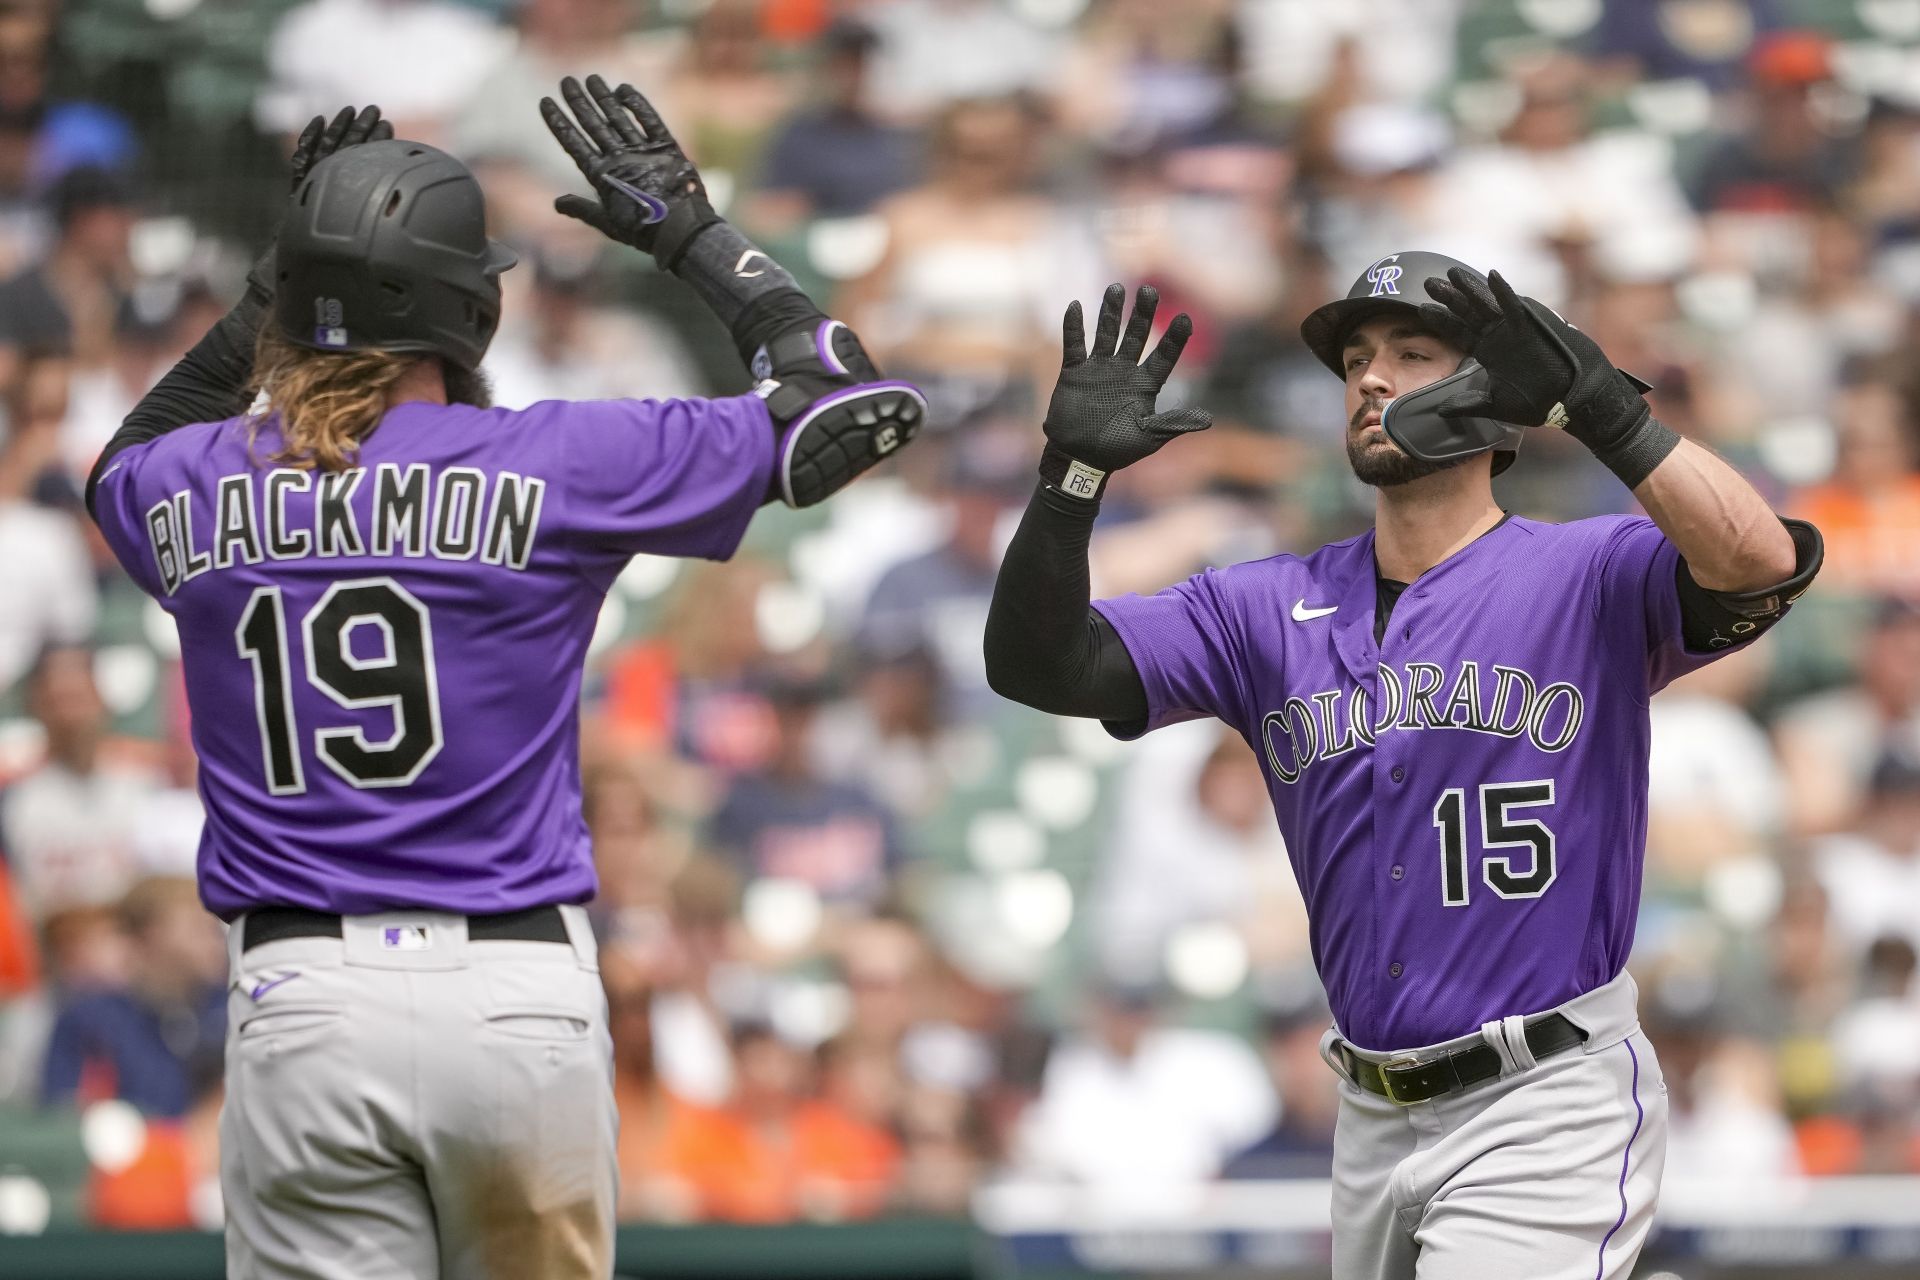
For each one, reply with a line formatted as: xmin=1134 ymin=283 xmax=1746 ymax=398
xmin=86 ymin=79 xmax=924 ymax=1280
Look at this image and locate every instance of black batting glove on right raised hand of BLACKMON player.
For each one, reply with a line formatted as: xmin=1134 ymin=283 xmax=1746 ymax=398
xmin=540 ymin=75 xmax=720 ymax=271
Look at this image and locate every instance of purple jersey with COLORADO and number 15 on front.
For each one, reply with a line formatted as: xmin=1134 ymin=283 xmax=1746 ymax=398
xmin=1094 ymin=516 xmax=1728 ymax=1050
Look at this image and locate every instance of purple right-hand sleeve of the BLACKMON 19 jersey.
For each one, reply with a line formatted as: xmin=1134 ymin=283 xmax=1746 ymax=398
xmin=549 ymin=395 xmax=776 ymax=560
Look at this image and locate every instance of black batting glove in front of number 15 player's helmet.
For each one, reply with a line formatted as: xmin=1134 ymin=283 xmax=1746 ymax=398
xmin=1421 ymin=267 xmax=1680 ymax=487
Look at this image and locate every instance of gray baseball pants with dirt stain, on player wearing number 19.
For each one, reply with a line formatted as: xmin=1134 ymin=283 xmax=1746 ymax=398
xmin=221 ymin=908 xmax=618 ymax=1280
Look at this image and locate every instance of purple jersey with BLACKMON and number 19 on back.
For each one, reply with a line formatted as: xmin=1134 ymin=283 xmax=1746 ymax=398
xmin=94 ymin=395 xmax=776 ymax=919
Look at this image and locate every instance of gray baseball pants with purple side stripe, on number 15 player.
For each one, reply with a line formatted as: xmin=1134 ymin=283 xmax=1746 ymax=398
xmin=1321 ymin=973 xmax=1667 ymax=1280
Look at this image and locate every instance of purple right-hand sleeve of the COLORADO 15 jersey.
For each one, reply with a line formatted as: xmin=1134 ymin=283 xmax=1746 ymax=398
xmin=1596 ymin=516 xmax=1751 ymax=695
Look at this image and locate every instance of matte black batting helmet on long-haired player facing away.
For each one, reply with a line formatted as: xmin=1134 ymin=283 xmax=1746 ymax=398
xmin=273 ymin=138 xmax=515 ymax=368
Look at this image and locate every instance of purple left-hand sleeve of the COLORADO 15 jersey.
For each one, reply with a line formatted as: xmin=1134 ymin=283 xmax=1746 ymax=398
xmin=1092 ymin=568 xmax=1252 ymax=739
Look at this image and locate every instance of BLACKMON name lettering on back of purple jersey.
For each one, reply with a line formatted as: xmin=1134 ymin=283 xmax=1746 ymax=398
xmin=146 ymin=462 xmax=547 ymax=595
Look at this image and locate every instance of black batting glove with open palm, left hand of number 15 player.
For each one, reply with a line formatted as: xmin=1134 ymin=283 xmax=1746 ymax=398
xmin=1041 ymin=284 xmax=1213 ymax=501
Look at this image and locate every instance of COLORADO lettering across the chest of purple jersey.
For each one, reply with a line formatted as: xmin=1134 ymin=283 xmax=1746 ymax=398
xmin=1260 ymin=660 xmax=1586 ymax=783
